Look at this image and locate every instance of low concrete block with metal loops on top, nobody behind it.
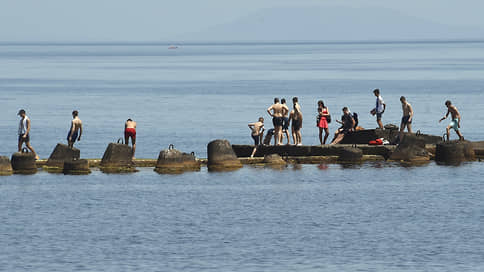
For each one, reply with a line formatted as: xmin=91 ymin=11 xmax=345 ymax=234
xmin=154 ymin=145 xmax=201 ymax=174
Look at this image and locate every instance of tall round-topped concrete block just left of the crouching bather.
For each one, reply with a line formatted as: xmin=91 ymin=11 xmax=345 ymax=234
xmin=207 ymin=140 xmax=242 ymax=171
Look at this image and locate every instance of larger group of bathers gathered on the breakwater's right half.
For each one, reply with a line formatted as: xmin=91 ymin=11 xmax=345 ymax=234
xmin=249 ymin=89 xmax=464 ymax=153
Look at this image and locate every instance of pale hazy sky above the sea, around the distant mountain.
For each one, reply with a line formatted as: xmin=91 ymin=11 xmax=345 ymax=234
xmin=0 ymin=0 xmax=484 ymax=42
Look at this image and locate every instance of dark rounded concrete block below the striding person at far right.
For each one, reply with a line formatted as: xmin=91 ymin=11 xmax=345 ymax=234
xmin=435 ymin=141 xmax=476 ymax=164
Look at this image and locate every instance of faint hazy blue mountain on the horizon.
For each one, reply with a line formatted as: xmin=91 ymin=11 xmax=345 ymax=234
xmin=184 ymin=6 xmax=484 ymax=41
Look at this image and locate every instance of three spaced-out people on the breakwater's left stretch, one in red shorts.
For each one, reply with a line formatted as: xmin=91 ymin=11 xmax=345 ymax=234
xmin=17 ymin=109 xmax=136 ymax=160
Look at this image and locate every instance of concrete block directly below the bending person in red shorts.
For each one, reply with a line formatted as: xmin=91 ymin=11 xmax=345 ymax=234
xmin=99 ymin=143 xmax=136 ymax=173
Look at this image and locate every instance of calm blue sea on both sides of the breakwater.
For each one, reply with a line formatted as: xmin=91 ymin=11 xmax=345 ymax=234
xmin=0 ymin=40 xmax=484 ymax=271
